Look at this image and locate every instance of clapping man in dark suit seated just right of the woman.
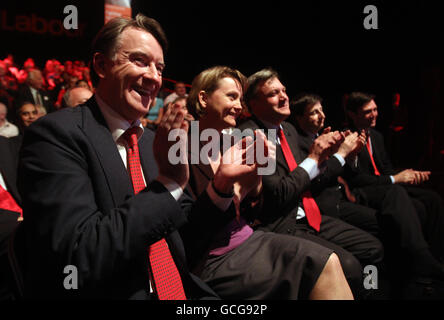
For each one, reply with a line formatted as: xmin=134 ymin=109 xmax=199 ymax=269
xmin=240 ymin=69 xmax=382 ymax=298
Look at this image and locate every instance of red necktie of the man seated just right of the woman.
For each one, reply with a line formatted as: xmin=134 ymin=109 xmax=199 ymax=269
xmin=278 ymin=129 xmax=322 ymax=232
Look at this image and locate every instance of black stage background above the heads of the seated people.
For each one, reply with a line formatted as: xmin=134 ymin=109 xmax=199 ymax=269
xmin=0 ymin=0 xmax=444 ymax=192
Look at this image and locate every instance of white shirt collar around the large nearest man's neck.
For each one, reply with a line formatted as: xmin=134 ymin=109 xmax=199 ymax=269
xmin=95 ymin=94 xmax=144 ymax=143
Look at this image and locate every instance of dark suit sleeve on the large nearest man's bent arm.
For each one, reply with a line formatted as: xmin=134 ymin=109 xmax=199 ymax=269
xmin=18 ymin=115 xmax=185 ymax=287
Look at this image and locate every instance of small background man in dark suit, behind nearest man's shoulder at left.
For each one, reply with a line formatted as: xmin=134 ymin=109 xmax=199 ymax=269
xmin=17 ymin=69 xmax=55 ymax=113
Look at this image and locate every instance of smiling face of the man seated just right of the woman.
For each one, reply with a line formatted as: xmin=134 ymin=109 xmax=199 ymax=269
xmin=250 ymin=77 xmax=290 ymax=125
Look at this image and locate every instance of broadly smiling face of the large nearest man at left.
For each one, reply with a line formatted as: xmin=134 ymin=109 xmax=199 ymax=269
xmin=94 ymin=28 xmax=164 ymax=122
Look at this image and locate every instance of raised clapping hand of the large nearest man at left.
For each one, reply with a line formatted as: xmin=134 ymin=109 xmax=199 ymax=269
xmin=153 ymin=102 xmax=190 ymax=190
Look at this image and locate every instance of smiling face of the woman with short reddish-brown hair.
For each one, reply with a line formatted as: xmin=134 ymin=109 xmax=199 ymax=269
xmin=199 ymin=77 xmax=243 ymax=132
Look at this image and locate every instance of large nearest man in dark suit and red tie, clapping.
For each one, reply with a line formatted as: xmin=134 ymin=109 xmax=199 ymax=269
xmin=18 ymin=15 xmax=217 ymax=299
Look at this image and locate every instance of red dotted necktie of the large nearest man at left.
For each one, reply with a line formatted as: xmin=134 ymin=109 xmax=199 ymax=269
xmin=124 ymin=127 xmax=186 ymax=300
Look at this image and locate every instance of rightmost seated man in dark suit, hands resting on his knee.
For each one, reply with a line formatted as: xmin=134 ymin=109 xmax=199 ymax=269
xmin=346 ymin=92 xmax=444 ymax=288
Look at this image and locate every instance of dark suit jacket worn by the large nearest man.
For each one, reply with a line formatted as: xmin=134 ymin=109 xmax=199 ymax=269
xmin=19 ymin=97 xmax=217 ymax=299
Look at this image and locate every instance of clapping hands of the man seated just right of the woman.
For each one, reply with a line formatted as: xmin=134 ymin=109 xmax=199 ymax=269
xmin=308 ymin=131 xmax=344 ymax=165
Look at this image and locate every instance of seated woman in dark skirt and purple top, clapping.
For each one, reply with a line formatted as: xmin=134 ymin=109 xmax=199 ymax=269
xmin=180 ymin=66 xmax=353 ymax=300
